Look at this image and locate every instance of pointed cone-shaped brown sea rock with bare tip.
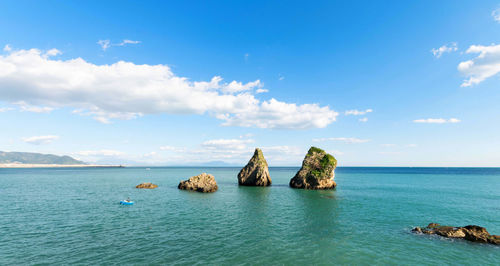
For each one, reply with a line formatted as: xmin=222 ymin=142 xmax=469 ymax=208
xmin=238 ymin=148 xmax=271 ymax=187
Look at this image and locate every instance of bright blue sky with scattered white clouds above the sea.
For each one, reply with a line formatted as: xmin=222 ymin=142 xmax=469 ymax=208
xmin=0 ymin=0 xmax=500 ymax=167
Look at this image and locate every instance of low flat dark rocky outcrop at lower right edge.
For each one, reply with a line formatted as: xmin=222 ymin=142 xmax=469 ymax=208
xmin=412 ymin=223 xmax=500 ymax=245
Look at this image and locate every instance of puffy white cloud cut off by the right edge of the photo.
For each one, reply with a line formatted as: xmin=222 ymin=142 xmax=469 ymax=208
xmin=458 ymin=44 xmax=500 ymax=87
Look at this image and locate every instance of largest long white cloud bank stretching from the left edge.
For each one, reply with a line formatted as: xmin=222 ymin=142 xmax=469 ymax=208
xmin=0 ymin=49 xmax=338 ymax=129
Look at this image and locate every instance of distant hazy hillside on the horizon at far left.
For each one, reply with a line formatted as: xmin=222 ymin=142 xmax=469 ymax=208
xmin=0 ymin=151 xmax=85 ymax=164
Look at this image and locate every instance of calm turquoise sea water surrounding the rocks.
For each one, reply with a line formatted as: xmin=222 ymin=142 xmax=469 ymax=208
xmin=0 ymin=168 xmax=500 ymax=265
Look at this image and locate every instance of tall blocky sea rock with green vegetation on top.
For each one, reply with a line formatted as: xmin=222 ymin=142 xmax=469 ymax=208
xmin=290 ymin=147 xmax=337 ymax=189
